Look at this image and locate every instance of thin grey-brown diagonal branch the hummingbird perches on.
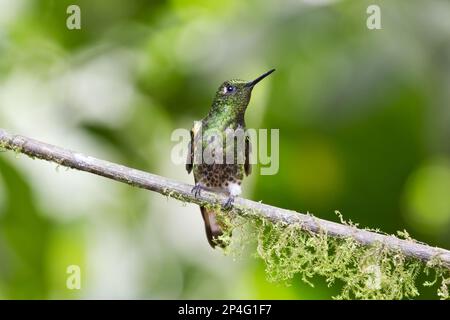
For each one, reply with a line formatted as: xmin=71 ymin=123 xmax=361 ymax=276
xmin=0 ymin=129 xmax=450 ymax=269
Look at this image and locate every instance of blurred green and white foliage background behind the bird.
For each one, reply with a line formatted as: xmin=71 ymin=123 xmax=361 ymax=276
xmin=0 ymin=0 xmax=450 ymax=299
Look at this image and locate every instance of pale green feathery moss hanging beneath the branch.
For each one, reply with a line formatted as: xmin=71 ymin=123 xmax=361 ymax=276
xmin=220 ymin=212 xmax=450 ymax=299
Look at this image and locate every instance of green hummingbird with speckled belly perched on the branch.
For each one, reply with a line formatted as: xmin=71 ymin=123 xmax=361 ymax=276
xmin=186 ymin=69 xmax=275 ymax=248
